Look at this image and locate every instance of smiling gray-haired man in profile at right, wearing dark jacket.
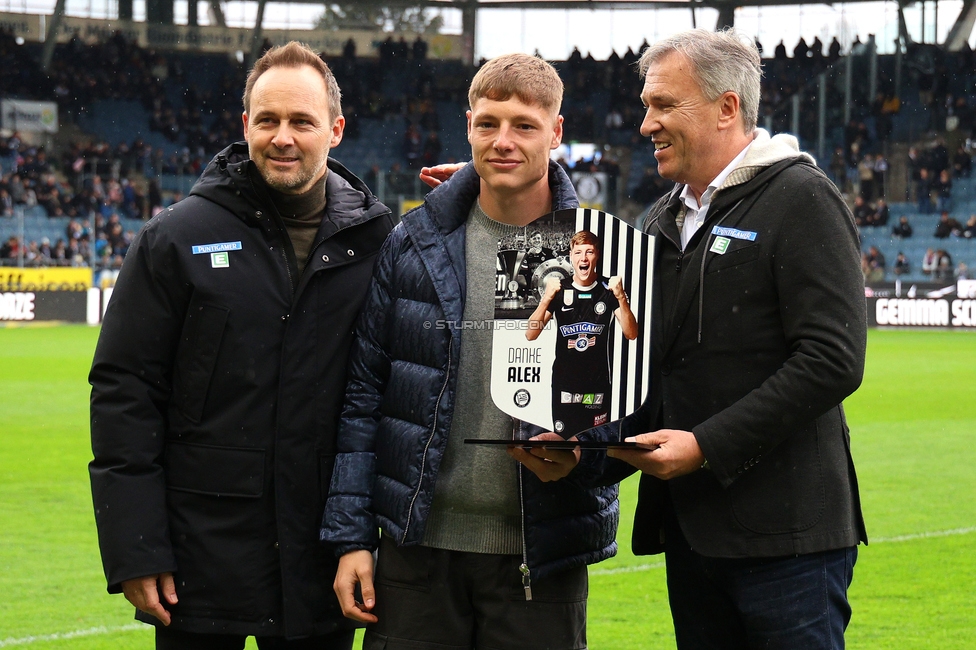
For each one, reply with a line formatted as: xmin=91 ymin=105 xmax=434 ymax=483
xmin=575 ymin=30 xmax=867 ymax=650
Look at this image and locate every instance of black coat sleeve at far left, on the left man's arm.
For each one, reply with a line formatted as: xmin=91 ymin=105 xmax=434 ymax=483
xmin=89 ymin=224 xmax=189 ymax=593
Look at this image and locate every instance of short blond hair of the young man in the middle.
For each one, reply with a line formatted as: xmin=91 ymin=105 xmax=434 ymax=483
xmin=468 ymin=53 xmax=563 ymax=117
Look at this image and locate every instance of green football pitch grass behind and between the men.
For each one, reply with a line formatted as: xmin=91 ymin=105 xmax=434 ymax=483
xmin=0 ymin=326 xmax=976 ymax=650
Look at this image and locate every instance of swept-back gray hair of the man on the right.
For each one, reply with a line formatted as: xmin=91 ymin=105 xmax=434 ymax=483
xmin=637 ymin=29 xmax=762 ymax=133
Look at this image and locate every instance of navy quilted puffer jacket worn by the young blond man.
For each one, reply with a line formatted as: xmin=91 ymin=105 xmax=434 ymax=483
xmin=321 ymin=164 xmax=619 ymax=578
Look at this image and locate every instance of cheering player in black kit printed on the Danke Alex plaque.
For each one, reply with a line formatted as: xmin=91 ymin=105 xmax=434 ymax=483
xmin=525 ymin=230 xmax=637 ymax=438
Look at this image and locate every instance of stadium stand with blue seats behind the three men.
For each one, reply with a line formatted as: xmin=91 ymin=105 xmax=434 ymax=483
xmin=0 ymin=31 xmax=976 ymax=281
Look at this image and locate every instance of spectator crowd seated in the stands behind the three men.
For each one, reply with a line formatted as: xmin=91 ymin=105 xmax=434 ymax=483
xmin=0 ymin=30 xmax=976 ymax=278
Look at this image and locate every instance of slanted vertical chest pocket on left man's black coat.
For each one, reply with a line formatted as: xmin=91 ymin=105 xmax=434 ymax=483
xmin=173 ymin=303 xmax=230 ymax=423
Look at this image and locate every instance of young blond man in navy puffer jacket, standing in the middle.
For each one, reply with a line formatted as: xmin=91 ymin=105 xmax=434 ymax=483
xmin=322 ymin=54 xmax=618 ymax=650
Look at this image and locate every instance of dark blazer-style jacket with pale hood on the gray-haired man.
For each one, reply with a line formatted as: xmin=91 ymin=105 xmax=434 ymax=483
xmin=578 ymin=129 xmax=867 ymax=557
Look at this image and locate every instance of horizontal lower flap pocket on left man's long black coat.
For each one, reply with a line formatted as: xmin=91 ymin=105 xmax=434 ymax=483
xmin=163 ymin=441 xmax=264 ymax=499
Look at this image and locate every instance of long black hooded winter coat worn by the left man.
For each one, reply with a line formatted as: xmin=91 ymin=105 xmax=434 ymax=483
xmin=89 ymin=143 xmax=393 ymax=637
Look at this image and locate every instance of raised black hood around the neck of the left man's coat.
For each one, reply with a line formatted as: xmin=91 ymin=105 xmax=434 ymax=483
xmin=190 ymin=142 xmax=390 ymax=232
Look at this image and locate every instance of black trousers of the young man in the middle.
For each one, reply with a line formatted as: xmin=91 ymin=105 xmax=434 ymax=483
xmin=363 ymin=535 xmax=588 ymax=650
